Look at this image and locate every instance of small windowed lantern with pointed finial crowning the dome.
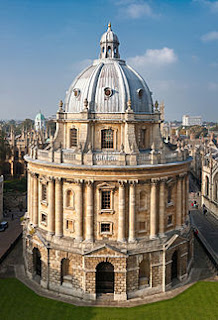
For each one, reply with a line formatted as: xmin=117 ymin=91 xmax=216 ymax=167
xmin=100 ymin=22 xmax=120 ymax=59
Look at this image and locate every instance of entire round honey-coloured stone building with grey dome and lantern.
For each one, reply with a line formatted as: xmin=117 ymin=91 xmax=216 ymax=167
xmin=23 ymin=24 xmax=193 ymax=300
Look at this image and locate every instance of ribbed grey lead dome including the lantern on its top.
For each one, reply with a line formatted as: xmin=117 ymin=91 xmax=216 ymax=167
xmin=65 ymin=24 xmax=153 ymax=113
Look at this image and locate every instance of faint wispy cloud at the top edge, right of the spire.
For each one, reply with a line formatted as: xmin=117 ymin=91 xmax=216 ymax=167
xmin=116 ymin=0 xmax=159 ymax=19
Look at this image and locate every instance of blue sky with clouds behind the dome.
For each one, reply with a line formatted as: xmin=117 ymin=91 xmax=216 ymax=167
xmin=0 ymin=0 xmax=218 ymax=121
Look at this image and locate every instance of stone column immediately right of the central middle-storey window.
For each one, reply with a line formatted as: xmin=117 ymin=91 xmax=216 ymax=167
xmin=117 ymin=181 xmax=125 ymax=242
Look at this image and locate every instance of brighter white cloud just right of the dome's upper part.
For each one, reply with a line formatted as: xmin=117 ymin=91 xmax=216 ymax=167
xmin=128 ymin=47 xmax=178 ymax=67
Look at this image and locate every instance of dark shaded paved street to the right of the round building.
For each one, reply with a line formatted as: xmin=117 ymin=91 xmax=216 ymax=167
xmin=190 ymin=210 xmax=218 ymax=259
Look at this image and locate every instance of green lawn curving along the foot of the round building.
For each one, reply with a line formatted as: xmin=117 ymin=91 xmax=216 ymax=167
xmin=0 ymin=279 xmax=218 ymax=320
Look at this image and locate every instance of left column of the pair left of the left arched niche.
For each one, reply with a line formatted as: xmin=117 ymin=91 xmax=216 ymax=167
xmin=48 ymin=177 xmax=55 ymax=235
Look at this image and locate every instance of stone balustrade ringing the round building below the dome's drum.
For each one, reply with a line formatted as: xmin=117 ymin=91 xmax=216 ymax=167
xmin=28 ymin=146 xmax=188 ymax=166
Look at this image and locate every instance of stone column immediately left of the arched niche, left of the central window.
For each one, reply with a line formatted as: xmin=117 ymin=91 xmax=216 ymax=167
xmin=55 ymin=177 xmax=63 ymax=237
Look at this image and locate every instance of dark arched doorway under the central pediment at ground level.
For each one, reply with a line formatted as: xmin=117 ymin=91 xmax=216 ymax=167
xmin=96 ymin=262 xmax=114 ymax=294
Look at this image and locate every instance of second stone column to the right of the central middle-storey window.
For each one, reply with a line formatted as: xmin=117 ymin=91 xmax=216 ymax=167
xmin=129 ymin=181 xmax=136 ymax=242
